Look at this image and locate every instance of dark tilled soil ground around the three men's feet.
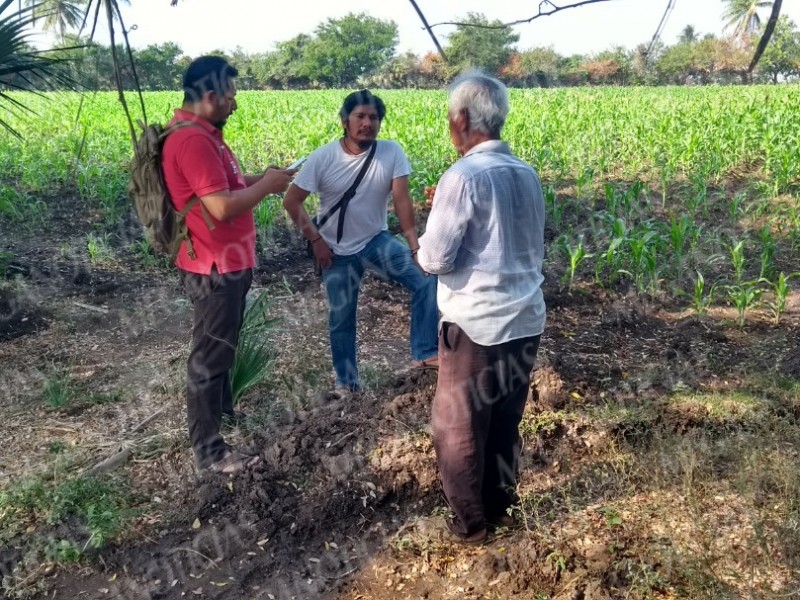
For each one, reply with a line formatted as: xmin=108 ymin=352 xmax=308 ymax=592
xmin=0 ymin=198 xmax=800 ymax=600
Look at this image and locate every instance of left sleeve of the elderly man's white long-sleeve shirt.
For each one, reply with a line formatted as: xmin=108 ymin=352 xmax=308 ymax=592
xmin=417 ymin=166 xmax=474 ymax=275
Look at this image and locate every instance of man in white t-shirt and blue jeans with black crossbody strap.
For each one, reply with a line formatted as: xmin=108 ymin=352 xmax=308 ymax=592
xmin=283 ymin=90 xmax=438 ymax=397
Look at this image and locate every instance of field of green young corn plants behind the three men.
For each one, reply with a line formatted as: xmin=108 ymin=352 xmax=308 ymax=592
xmin=0 ymin=85 xmax=800 ymax=325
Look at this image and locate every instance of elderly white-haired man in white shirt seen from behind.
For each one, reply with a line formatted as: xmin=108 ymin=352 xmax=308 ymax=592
xmin=417 ymin=73 xmax=545 ymax=544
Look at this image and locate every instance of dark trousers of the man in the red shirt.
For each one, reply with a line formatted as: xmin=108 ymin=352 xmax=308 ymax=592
xmin=180 ymin=268 xmax=253 ymax=468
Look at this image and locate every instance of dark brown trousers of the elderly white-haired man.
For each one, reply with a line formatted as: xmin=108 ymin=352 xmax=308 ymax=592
xmin=432 ymin=322 xmax=541 ymax=536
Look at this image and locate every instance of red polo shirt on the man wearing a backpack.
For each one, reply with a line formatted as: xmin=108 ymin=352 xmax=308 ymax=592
xmin=162 ymin=109 xmax=256 ymax=275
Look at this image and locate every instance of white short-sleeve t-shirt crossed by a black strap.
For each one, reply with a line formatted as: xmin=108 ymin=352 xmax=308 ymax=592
xmin=294 ymin=140 xmax=411 ymax=256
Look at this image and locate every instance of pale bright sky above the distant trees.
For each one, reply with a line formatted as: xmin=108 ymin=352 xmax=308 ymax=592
xmin=32 ymin=0 xmax=800 ymax=56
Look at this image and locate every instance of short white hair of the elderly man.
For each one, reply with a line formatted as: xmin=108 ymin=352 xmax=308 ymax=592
xmin=448 ymin=71 xmax=508 ymax=136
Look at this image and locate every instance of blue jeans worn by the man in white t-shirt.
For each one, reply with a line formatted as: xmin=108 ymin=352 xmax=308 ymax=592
xmin=322 ymin=231 xmax=439 ymax=390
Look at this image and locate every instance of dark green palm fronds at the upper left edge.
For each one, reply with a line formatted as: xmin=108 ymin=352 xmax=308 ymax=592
xmin=0 ymin=0 xmax=75 ymax=137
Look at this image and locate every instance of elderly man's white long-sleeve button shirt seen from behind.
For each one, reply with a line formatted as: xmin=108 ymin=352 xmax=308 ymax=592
xmin=417 ymin=140 xmax=545 ymax=346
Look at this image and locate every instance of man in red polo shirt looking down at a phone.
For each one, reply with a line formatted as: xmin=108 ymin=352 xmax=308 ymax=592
xmin=162 ymin=56 xmax=292 ymax=474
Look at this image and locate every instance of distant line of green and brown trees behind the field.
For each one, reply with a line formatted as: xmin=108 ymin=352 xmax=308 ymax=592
xmin=48 ymin=13 xmax=800 ymax=90
